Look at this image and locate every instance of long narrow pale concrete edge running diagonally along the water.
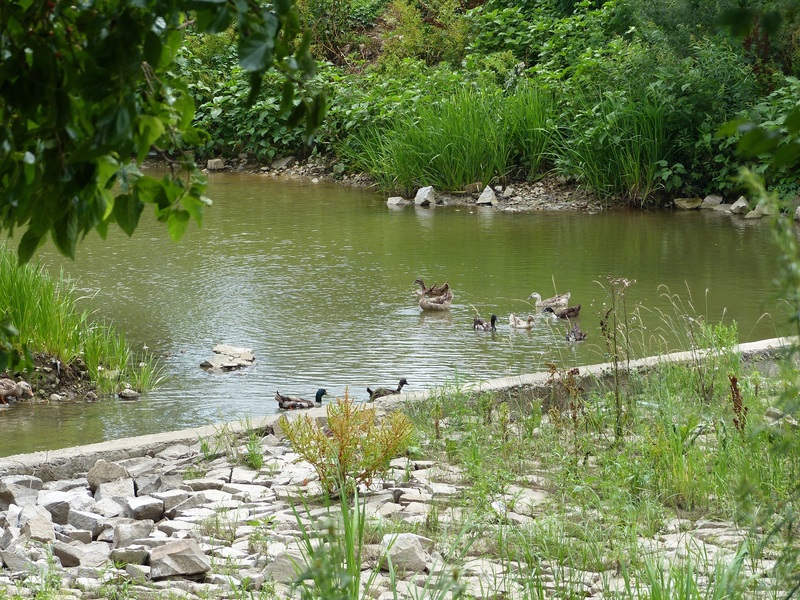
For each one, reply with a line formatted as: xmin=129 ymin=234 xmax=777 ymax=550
xmin=0 ymin=337 xmax=798 ymax=481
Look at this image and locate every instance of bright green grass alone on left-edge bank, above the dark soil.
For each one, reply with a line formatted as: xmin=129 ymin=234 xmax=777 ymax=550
xmin=0 ymin=241 xmax=163 ymax=393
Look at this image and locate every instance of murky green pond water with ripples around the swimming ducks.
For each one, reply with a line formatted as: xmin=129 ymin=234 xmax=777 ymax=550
xmin=0 ymin=173 xmax=784 ymax=456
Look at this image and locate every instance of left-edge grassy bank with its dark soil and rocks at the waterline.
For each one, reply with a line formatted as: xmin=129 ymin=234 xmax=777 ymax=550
xmin=0 ymin=244 xmax=163 ymax=402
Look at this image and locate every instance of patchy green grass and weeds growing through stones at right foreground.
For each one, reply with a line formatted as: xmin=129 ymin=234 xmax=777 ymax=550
xmin=406 ymin=342 xmax=800 ymax=598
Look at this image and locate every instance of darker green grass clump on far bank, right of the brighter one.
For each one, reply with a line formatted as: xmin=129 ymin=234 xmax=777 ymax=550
xmin=556 ymin=88 xmax=670 ymax=205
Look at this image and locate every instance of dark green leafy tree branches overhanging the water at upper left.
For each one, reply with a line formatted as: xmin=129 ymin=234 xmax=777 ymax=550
xmin=0 ymin=0 xmax=324 ymax=262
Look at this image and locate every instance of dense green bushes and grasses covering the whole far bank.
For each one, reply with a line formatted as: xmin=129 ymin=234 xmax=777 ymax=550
xmin=179 ymin=0 xmax=800 ymax=209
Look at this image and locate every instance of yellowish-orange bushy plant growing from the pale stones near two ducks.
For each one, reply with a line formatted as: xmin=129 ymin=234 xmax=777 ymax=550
xmin=280 ymin=394 xmax=412 ymax=494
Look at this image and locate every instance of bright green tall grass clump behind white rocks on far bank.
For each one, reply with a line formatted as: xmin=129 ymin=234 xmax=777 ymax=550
xmin=343 ymin=84 xmax=554 ymax=195
